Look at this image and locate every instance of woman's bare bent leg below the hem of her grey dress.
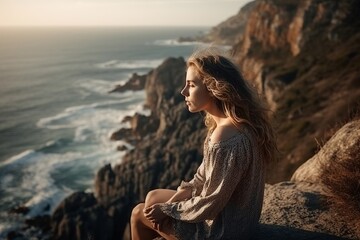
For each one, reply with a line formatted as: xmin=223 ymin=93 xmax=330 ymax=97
xmin=130 ymin=189 xmax=176 ymax=240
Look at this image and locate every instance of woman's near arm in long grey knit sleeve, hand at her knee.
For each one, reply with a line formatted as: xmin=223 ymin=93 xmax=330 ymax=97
xmin=159 ymin=137 xmax=251 ymax=223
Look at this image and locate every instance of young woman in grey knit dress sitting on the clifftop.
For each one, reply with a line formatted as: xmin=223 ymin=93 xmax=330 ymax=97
xmin=131 ymin=47 xmax=276 ymax=240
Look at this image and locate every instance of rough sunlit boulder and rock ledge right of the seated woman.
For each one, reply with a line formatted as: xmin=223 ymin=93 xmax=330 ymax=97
xmin=257 ymin=120 xmax=360 ymax=240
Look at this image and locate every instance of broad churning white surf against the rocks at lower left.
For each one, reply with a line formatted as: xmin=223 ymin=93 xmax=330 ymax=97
xmin=0 ymin=87 xmax=149 ymax=216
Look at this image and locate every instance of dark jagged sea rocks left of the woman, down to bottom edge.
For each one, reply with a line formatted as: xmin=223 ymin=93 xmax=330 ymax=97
xmin=52 ymin=58 xmax=206 ymax=239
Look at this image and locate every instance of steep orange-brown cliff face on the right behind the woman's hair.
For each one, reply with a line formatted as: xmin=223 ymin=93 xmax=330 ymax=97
xmin=228 ymin=0 xmax=360 ymax=182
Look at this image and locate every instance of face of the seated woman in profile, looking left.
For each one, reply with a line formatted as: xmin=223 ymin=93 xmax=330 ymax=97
xmin=181 ymin=66 xmax=215 ymax=112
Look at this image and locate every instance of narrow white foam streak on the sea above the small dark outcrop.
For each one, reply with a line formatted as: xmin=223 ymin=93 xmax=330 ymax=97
xmin=95 ymin=59 xmax=164 ymax=69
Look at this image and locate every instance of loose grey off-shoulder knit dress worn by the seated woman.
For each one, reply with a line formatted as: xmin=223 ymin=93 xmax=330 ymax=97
xmin=161 ymin=128 xmax=265 ymax=240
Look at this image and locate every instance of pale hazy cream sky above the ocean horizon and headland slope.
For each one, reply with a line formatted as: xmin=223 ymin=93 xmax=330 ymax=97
xmin=0 ymin=0 xmax=250 ymax=26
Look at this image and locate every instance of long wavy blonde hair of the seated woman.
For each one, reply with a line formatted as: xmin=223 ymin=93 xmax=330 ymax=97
xmin=187 ymin=48 xmax=277 ymax=162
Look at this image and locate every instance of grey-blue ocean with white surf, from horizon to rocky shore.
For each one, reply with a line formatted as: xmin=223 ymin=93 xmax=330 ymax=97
xmin=0 ymin=27 xmax=209 ymax=238
